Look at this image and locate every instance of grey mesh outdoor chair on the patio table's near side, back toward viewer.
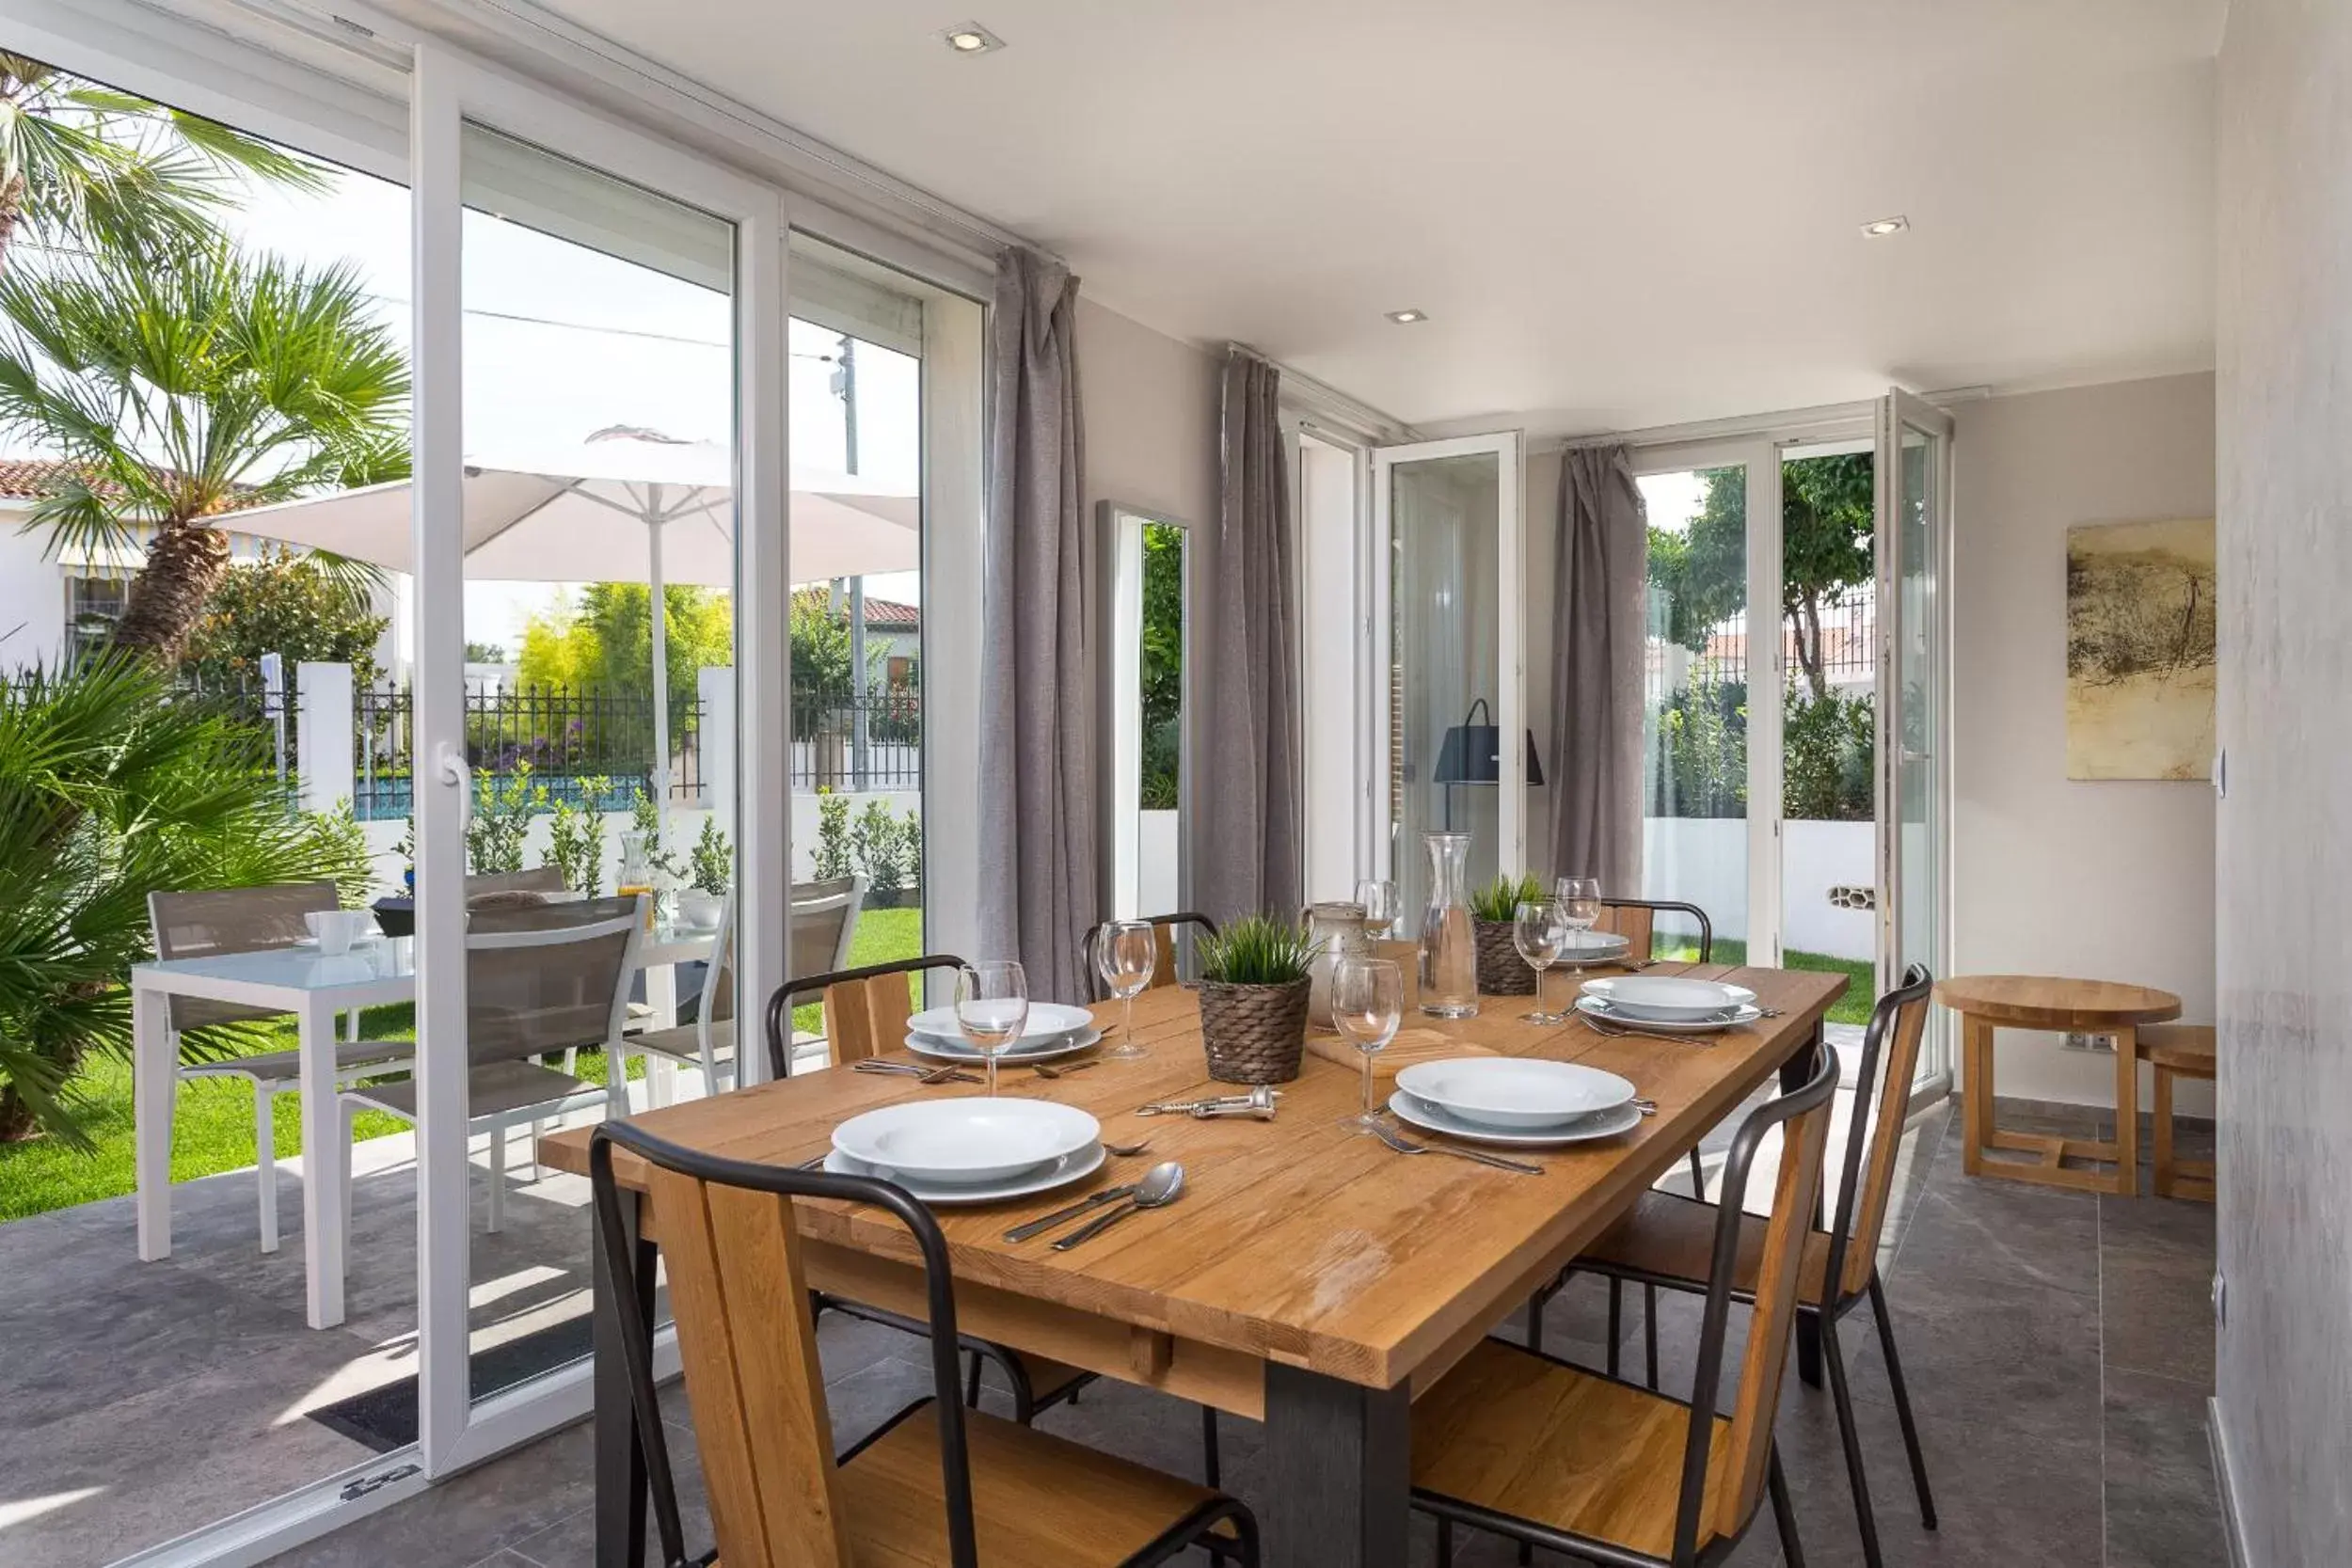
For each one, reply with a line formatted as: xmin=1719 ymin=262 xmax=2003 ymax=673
xmin=343 ymin=895 xmax=644 ymax=1239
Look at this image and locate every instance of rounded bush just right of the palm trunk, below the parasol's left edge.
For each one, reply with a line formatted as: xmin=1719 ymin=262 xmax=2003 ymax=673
xmin=182 ymin=546 xmax=390 ymax=687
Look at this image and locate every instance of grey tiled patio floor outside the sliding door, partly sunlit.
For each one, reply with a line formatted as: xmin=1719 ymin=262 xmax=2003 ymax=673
xmin=0 ymin=1114 xmax=616 ymax=1566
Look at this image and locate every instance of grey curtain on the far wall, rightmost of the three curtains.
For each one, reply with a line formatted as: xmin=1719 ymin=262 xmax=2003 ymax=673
xmin=1546 ymin=447 xmax=1649 ymax=898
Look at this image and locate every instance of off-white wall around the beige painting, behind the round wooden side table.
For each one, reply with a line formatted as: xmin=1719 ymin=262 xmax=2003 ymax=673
xmin=1952 ymin=376 xmax=2214 ymax=1115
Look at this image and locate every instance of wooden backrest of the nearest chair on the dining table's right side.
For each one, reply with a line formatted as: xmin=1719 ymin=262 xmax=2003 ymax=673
xmin=1675 ymin=1046 xmax=1837 ymax=1563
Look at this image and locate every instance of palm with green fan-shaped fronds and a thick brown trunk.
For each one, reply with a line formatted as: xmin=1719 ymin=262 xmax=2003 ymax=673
xmin=0 ymin=235 xmax=409 ymax=660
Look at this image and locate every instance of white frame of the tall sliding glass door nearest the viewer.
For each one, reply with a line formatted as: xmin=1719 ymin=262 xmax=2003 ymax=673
xmin=409 ymin=40 xmax=790 ymax=1477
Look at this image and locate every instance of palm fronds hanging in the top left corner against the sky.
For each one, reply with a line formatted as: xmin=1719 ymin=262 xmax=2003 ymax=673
xmin=0 ymin=52 xmax=329 ymax=278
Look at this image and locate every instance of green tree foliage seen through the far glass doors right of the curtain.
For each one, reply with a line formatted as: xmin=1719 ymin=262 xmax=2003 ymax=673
xmin=1649 ymin=451 xmax=1877 ymax=701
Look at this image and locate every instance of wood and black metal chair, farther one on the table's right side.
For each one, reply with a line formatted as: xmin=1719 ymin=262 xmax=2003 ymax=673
xmin=1569 ymin=964 xmax=1936 ymax=1568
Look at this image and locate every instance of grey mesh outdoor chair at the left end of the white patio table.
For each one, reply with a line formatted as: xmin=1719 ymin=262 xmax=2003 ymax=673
xmin=149 ymin=881 xmax=414 ymax=1253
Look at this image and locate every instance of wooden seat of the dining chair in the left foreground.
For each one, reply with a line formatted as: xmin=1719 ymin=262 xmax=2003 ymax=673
xmin=837 ymin=1402 xmax=1226 ymax=1568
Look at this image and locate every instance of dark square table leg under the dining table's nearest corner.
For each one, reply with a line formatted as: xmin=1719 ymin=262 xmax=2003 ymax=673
xmin=1259 ymin=1361 xmax=1414 ymax=1568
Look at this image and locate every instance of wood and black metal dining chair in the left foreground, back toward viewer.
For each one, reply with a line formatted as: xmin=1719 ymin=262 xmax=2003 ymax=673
xmin=588 ymin=1124 xmax=1259 ymax=1568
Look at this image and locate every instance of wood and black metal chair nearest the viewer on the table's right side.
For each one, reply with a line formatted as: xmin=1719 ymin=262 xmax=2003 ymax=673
xmin=1411 ymin=1046 xmax=1837 ymax=1568
